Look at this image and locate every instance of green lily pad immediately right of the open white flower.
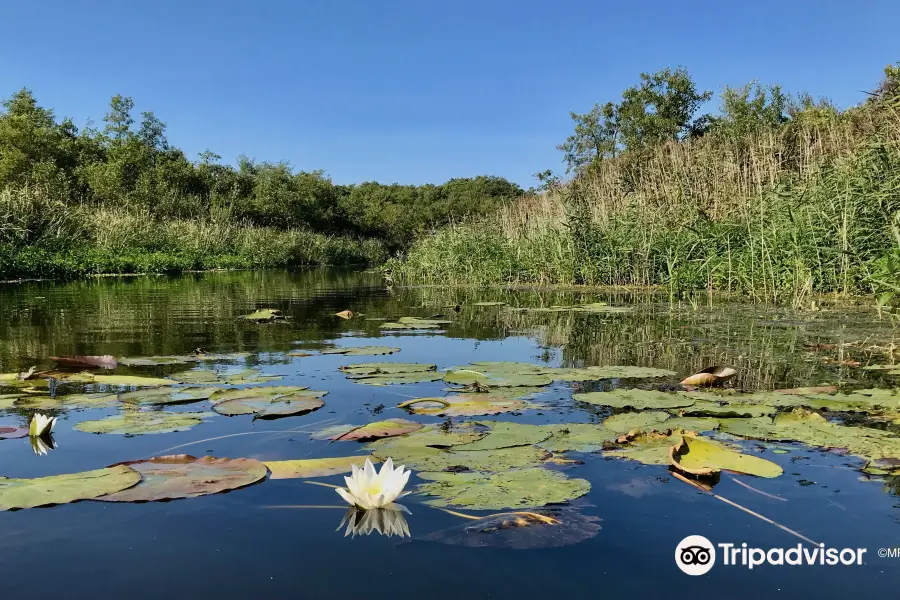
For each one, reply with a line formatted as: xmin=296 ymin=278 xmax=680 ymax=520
xmin=419 ymin=468 xmax=591 ymax=510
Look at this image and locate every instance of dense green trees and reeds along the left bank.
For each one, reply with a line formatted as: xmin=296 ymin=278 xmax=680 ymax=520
xmin=0 ymin=89 xmax=523 ymax=278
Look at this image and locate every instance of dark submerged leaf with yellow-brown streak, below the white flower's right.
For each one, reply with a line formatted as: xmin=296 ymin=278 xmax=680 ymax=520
xmin=420 ymin=508 xmax=600 ymax=550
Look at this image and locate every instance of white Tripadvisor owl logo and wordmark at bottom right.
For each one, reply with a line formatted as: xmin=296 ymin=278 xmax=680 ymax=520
xmin=675 ymin=535 xmax=867 ymax=575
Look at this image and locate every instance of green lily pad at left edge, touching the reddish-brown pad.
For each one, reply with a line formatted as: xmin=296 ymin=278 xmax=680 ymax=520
xmin=0 ymin=465 xmax=141 ymax=510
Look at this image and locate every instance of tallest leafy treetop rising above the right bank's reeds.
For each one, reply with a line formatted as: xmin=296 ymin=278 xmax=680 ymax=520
xmin=617 ymin=67 xmax=712 ymax=150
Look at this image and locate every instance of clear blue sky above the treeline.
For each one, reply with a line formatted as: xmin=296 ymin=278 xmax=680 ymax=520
xmin=0 ymin=0 xmax=900 ymax=187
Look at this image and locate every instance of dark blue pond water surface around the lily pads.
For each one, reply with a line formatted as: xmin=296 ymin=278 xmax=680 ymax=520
xmin=0 ymin=270 xmax=900 ymax=599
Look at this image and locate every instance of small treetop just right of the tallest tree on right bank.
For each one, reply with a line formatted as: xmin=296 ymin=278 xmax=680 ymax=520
xmin=711 ymin=81 xmax=788 ymax=139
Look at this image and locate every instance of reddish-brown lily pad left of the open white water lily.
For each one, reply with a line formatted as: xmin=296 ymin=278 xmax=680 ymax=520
xmin=96 ymin=454 xmax=267 ymax=502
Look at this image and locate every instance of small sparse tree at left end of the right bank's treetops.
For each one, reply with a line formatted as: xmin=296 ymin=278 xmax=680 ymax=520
xmin=556 ymin=102 xmax=619 ymax=173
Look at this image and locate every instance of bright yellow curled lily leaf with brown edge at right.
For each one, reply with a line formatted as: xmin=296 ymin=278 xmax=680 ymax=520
xmin=669 ymin=435 xmax=784 ymax=478
